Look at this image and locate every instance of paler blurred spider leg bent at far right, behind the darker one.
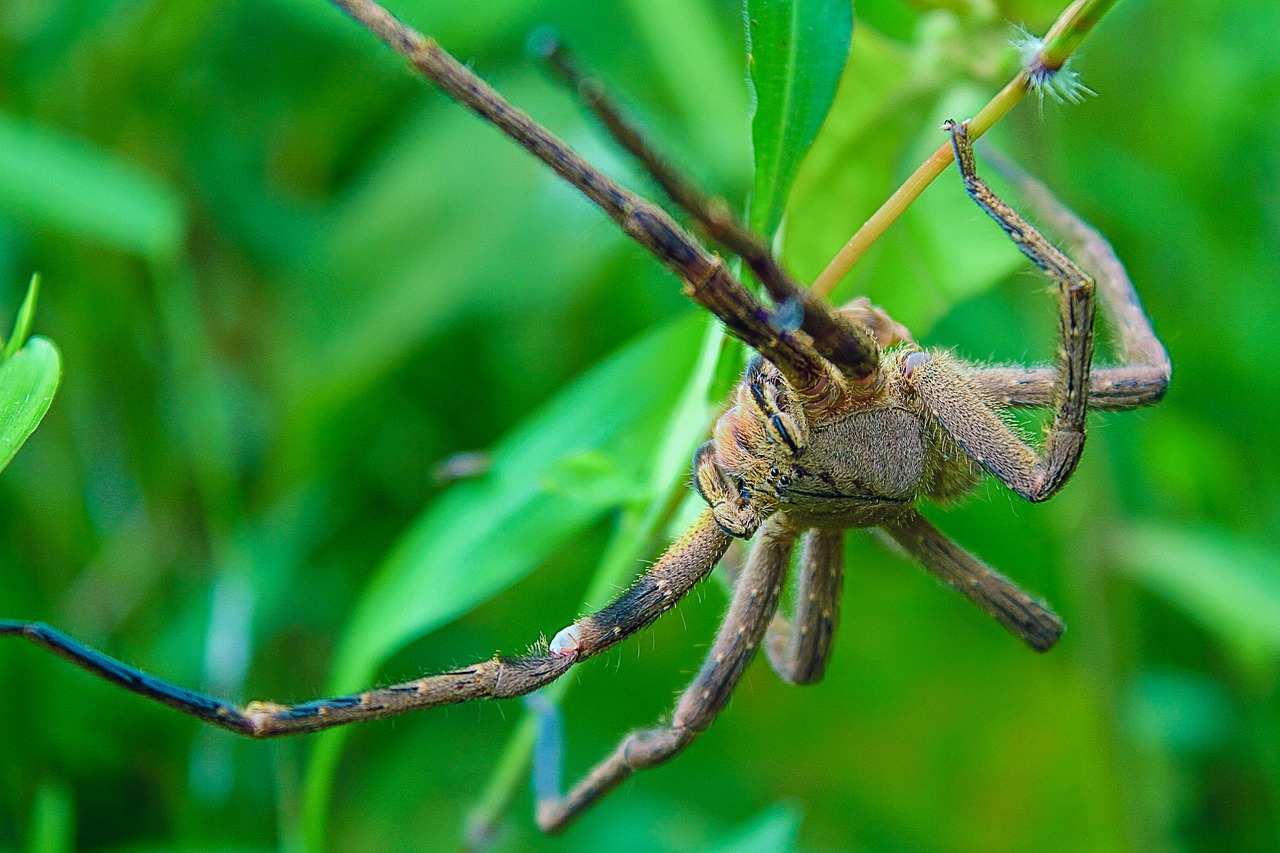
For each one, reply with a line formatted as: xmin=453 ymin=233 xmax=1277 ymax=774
xmin=972 ymin=148 xmax=1170 ymax=411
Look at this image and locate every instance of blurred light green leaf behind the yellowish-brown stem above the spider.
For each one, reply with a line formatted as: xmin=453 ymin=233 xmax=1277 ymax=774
xmin=786 ymin=39 xmax=1029 ymax=339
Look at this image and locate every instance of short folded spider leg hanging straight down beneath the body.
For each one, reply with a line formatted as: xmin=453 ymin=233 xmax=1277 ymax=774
xmin=764 ymin=529 xmax=845 ymax=684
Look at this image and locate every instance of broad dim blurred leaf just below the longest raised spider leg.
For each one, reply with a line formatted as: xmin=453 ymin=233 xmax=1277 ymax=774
xmin=276 ymin=83 xmax=623 ymax=435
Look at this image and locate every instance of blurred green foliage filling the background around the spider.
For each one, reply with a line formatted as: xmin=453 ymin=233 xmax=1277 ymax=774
xmin=0 ymin=0 xmax=1280 ymax=852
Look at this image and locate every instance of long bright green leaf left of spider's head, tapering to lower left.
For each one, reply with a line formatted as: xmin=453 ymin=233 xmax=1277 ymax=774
xmin=302 ymin=315 xmax=704 ymax=843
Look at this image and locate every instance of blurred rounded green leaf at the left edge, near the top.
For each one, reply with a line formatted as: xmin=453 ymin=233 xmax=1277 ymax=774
xmin=0 ymin=113 xmax=186 ymax=257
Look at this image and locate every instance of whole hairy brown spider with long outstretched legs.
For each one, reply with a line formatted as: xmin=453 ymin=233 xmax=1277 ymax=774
xmin=0 ymin=0 xmax=1170 ymax=833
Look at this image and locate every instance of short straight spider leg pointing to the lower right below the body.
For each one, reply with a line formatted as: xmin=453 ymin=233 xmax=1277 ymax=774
xmin=882 ymin=511 xmax=1065 ymax=652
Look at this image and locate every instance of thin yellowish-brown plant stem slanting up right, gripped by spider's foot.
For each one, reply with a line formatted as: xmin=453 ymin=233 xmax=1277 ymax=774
xmin=810 ymin=0 xmax=1116 ymax=297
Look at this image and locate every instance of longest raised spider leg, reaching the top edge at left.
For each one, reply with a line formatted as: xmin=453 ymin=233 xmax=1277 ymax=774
xmin=332 ymin=0 xmax=855 ymax=405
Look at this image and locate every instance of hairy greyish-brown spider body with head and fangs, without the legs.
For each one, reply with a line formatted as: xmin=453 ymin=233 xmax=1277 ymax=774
xmin=694 ymin=298 xmax=982 ymax=538
